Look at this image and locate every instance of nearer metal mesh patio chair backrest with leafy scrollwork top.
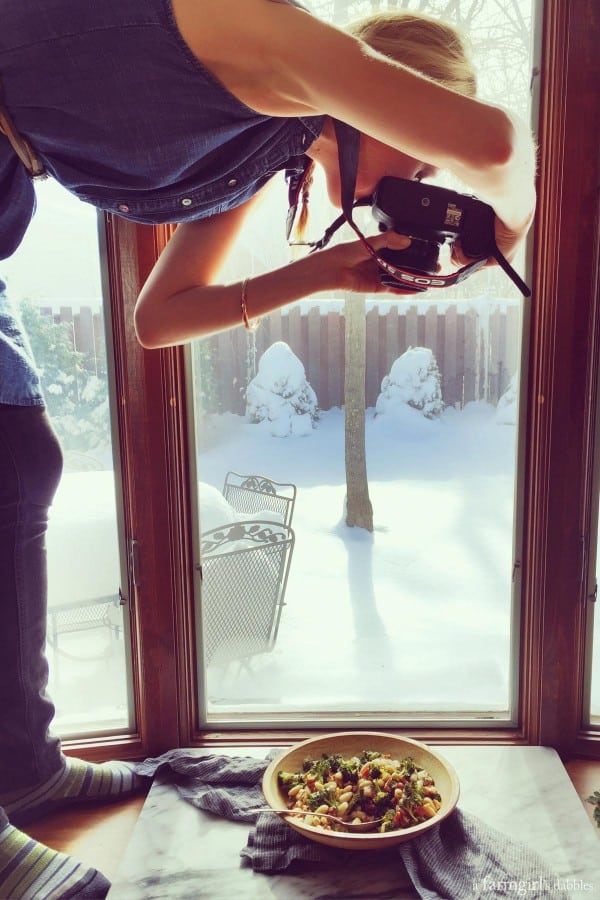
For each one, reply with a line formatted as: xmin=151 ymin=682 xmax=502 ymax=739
xmin=200 ymin=520 xmax=295 ymax=663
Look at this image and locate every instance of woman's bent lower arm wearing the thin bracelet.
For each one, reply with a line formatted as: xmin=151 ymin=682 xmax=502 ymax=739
xmin=134 ymin=193 xmax=410 ymax=349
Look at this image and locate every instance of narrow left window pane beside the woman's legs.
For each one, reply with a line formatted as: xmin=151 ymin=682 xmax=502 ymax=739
xmin=2 ymin=180 xmax=132 ymax=736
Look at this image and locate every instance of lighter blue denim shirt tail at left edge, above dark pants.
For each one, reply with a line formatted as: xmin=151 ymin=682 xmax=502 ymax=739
xmin=0 ymin=279 xmax=44 ymax=406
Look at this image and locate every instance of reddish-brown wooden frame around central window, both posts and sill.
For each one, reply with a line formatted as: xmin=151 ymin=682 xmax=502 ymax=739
xmin=64 ymin=0 xmax=600 ymax=758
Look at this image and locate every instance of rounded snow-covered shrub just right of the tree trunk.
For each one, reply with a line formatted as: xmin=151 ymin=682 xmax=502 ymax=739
xmin=375 ymin=347 xmax=444 ymax=419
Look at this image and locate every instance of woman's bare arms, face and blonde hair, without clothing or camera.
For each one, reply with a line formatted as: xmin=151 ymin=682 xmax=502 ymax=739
xmin=135 ymin=0 xmax=535 ymax=347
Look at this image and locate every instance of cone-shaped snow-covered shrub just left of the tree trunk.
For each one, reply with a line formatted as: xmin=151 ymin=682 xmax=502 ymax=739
xmin=246 ymin=341 xmax=318 ymax=437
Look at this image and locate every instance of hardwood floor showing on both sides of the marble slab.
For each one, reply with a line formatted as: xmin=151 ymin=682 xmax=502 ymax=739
xmin=18 ymin=759 xmax=600 ymax=880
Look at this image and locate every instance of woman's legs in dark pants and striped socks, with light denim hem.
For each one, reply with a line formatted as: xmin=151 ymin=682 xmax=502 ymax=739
xmin=0 ymin=280 xmax=146 ymax=900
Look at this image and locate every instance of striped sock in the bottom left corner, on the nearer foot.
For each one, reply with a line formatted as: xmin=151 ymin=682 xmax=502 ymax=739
xmin=0 ymin=825 xmax=110 ymax=900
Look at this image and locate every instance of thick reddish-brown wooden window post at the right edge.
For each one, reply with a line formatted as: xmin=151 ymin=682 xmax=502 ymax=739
xmin=521 ymin=0 xmax=600 ymax=757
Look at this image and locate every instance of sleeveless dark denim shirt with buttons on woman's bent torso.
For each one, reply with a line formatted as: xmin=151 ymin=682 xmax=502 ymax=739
xmin=0 ymin=0 xmax=324 ymax=259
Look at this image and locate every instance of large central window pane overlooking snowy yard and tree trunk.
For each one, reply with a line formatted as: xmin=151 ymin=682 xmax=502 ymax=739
xmin=194 ymin=2 xmax=537 ymax=727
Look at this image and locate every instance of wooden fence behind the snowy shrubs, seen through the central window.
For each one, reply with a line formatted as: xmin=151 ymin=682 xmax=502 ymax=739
xmin=197 ymin=304 xmax=520 ymax=415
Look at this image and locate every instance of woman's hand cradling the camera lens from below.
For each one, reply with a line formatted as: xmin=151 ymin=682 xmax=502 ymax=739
xmin=314 ymin=231 xmax=412 ymax=294
